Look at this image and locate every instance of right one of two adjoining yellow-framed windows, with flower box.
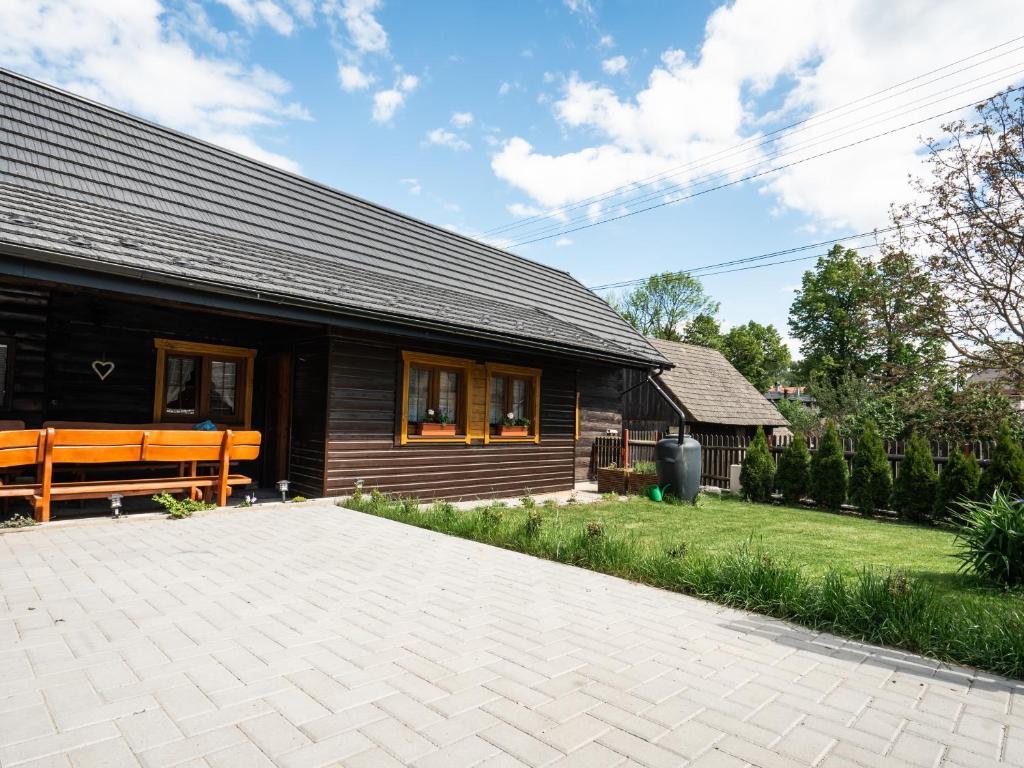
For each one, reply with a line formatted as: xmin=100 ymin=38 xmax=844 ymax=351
xmin=483 ymin=362 xmax=541 ymax=442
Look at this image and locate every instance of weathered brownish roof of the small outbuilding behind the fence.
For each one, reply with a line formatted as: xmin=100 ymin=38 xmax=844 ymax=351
xmin=648 ymin=339 xmax=788 ymax=427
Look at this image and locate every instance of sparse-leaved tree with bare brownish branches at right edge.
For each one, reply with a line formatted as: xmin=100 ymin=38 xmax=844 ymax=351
xmin=891 ymin=90 xmax=1024 ymax=391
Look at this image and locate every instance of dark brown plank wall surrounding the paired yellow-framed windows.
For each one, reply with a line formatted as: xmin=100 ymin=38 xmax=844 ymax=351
xmin=327 ymin=335 xmax=575 ymax=499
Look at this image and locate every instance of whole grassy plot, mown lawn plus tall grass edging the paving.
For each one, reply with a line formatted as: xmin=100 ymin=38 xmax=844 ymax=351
xmin=345 ymin=496 xmax=1024 ymax=679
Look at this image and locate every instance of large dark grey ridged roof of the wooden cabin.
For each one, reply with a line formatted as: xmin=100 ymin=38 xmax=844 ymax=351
xmin=0 ymin=69 xmax=665 ymax=366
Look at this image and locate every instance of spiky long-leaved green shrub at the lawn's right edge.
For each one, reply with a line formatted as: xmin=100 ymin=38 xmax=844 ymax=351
xmin=956 ymin=489 xmax=1024 ymax=585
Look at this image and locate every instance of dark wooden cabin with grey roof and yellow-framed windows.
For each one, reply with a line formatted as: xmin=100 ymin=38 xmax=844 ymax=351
xmin=0 ymin=70 xmax=671 ymax=518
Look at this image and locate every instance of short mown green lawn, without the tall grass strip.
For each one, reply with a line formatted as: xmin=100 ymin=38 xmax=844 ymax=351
xmin=544 ymin=497 xmax=1024 ymax=609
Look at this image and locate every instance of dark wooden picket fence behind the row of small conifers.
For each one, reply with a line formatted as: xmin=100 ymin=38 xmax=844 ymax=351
xmin=591 ymin=429 xmax=994 ymax=488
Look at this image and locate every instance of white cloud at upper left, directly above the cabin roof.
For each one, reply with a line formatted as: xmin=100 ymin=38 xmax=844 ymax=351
xmin=0 ymin=0 xmax=309 ymax=171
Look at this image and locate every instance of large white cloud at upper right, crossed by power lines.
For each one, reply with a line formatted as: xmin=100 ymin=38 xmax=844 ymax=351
xmin=492 ymin=0 xmax=1024 ymax=229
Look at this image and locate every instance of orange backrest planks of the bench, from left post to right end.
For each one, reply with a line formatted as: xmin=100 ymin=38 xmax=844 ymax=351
xmin=51 ymin=429 xmax=260 ymax=464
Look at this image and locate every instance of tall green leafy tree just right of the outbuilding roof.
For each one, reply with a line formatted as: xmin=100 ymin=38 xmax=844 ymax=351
xmin=790 ymin=245 xmax=874 ymax=381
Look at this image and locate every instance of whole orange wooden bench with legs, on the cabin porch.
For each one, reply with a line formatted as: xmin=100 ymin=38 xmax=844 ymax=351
xmin=0 ymin=427 xmax=260 ymax=522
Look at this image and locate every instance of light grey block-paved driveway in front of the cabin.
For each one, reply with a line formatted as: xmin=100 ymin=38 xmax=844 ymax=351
xmin=0 ymin=503 xmax=1024 ymax=768
